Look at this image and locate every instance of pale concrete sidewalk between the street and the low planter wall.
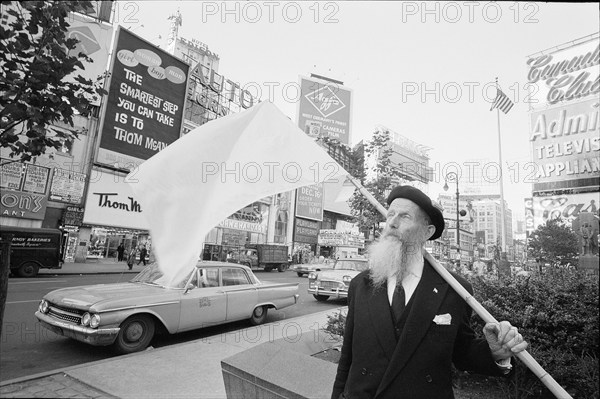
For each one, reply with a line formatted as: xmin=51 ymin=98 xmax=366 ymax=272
xmin=0 ymin=308 xmax=345 ymax=399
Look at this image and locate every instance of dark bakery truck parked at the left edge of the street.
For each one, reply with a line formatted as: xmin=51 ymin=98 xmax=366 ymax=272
xmin=1 ymin=226 xmax=67 ymax=277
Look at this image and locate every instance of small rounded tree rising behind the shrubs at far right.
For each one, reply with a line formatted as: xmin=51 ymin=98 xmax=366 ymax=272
xmin=527 ymin=219 xmax=578 ymax=266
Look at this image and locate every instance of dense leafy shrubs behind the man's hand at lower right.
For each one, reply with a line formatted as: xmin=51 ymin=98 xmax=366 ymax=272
xmin=471 ymin=270 xmax=599 ymax=398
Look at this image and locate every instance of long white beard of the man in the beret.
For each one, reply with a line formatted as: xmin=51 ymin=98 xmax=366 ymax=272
xmin=368 ymin=235 xmax=407 ymax=289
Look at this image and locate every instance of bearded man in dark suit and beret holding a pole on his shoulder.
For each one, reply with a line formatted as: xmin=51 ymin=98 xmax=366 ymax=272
xmin=331 ymin=186 xmax=527 ymax=399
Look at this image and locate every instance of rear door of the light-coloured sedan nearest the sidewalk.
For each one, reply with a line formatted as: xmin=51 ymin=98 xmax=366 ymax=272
xmin=221 ymin=267 xmax=258 ymax=321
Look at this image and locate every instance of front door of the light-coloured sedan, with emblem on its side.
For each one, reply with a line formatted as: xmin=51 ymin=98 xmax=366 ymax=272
xmin=178 ymin=267 xmax=227 ymax=332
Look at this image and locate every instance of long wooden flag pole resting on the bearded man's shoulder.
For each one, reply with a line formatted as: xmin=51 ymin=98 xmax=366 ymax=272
xmin=348 ymin=176 xmax=573 ymax=399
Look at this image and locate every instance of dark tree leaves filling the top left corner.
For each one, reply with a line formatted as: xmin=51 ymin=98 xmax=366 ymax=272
xmin=0 ymin=1 xmax=105 ymax=162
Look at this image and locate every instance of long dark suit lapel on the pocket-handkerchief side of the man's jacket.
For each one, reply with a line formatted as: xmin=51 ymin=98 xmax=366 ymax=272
xmin=377 ymin=261 xmax=448 ymax=394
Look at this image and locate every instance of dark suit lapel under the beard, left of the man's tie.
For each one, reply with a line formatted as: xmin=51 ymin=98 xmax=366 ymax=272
xmin=365 ymin=276 xmax=396 ymax=361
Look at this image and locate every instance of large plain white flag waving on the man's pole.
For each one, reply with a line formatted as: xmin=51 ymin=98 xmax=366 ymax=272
xmin=127 ymin=101 xmax=347 ymax=283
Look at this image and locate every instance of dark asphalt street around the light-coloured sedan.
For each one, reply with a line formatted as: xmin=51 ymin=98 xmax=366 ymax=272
xmin=0 ymin=270 xmax=345 ymax=381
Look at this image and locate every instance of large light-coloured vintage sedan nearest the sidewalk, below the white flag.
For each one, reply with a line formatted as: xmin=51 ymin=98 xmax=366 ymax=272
xmin=35 ymin=261 xmax=299 ymax=353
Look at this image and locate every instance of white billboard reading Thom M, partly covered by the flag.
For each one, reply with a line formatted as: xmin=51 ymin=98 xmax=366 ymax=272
xmin=83 ymin=171 xmax=148 ymax=230
